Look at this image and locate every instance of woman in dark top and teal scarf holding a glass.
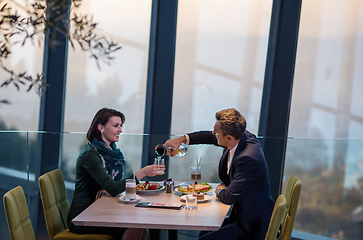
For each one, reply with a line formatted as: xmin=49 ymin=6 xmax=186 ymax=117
xmin=67 ymin=108 xmax=165 ymax=240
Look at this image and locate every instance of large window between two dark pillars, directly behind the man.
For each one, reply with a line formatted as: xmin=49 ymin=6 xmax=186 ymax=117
xmin=169 ymin=0 xmax=272 ymax=189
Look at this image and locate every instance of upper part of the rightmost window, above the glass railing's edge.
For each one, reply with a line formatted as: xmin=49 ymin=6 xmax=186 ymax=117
xmin=289 ymin=0 xmax=363 ymax=138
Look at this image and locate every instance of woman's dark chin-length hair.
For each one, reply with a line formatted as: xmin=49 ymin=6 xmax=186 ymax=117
xmin=87 ymin=108 xmax=126 ymax=141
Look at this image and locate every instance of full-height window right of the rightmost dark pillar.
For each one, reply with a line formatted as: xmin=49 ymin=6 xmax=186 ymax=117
xmin=285 ymin=0 xmax=363 ymax=239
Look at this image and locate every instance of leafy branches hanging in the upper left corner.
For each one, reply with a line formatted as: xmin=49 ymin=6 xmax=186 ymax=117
xmin=0 ymin=0 xmax=121 ymax=103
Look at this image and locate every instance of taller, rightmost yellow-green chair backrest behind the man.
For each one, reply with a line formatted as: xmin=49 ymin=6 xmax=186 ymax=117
xmin=280 ymin=175 xmax=302 ymax=240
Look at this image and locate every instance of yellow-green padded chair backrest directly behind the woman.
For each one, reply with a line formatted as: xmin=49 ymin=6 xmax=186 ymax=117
xmin=39 ymin=169 xmax=69 ymax=239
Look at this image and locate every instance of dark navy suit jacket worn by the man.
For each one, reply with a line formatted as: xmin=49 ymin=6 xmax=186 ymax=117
xmin=188 ymin=131 xmax=274 ymax=240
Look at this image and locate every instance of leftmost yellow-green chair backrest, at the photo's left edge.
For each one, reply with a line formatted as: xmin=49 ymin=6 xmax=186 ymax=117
xmin=4 ymin=186 xmax=35 ymax=240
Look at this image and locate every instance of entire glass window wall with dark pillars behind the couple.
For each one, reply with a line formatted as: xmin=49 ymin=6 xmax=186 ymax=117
xmin=0 ymin=0 xmax=363 ymax=240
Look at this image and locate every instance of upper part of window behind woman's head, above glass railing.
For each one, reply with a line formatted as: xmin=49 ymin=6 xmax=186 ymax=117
xmin=64 ymin=0 xmax=151 ymax=133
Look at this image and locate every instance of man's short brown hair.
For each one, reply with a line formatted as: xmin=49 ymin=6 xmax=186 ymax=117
xmin=216 ymin=108 xmax=247 ymax=139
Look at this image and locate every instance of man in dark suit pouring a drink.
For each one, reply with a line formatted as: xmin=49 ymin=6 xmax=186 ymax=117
xmin=164 ymin=109 xmax=274 ymax=240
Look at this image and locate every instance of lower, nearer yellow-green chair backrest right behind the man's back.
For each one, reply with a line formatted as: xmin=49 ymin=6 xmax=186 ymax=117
xmin=265 ymin=194 xmax=286 ymax=240
